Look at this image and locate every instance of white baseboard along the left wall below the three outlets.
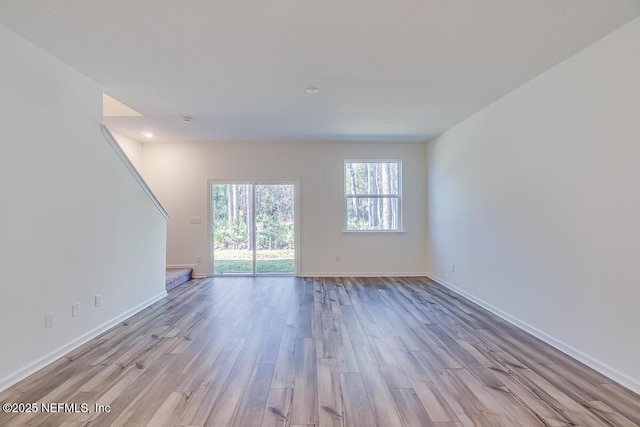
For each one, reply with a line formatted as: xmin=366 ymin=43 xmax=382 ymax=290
xmin=0 ymin=291 xmax=167 ymax=392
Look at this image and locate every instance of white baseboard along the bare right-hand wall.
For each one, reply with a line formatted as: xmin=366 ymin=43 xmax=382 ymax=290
xmin=426 ymin=273 xmax=640 ymax=394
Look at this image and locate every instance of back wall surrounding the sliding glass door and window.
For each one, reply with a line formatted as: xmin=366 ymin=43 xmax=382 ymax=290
xmin=143 ymin=142 xmax=426 ymax=275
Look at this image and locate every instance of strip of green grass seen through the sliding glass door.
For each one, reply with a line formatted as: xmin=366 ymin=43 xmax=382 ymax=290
xmin=213 ymin=249 xmax=295 ymax=274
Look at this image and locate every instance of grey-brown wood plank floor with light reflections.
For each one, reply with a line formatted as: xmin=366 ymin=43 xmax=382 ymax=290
xmin=0 ymin=277 xmax=640 ymax=427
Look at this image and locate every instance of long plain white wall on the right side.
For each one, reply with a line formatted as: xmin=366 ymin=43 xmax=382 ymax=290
xmin=428 ymin=19 xmax=640 ymax=391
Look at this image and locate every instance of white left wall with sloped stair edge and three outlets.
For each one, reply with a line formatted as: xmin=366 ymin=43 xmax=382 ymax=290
xmin=0 ymin=26 xmax=166 ymax=389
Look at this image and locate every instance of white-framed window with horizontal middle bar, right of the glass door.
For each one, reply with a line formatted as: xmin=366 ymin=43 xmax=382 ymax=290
xmin=344 ymin=160 xmax=402 ymax=231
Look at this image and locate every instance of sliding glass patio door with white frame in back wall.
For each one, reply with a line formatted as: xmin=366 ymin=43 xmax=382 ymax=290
xmin=210 ymin=181 xmax=296 ymax=276
